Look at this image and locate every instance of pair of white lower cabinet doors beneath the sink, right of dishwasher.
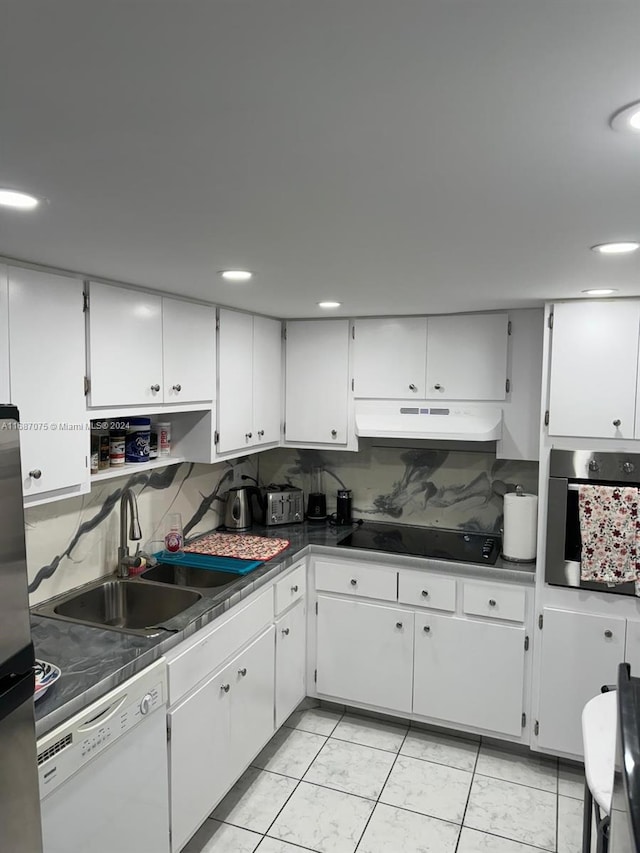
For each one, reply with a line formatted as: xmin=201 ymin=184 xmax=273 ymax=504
xmin=169 ymin=626 xmax=274 ymax=853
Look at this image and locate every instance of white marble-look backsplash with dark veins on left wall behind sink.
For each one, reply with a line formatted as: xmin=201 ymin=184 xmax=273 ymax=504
xmin=25 ymin=457 xmax=257 ymax=605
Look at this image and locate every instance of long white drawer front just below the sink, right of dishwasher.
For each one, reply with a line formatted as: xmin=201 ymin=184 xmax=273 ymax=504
xmin=167 ymin=589 xmax=273 ymax=705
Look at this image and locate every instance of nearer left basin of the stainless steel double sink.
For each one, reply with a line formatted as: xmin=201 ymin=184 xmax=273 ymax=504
xmin=34 ymin=578 xmax=202 ymax=637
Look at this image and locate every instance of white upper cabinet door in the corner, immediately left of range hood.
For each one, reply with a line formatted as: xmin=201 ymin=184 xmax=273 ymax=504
xmin=285 ymin=320 xmax=349 ymax=445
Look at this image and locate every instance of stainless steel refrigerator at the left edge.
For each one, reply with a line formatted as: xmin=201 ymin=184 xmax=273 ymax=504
xmin=0 ymin=404 xmax=42 ymax=853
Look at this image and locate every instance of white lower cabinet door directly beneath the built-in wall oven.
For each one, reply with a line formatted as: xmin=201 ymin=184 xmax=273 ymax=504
xmin=538 ymin=608 xmax=625 ymax=755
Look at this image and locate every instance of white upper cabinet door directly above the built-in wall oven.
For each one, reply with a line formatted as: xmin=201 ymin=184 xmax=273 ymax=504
xmin=549 ymin=299 xmax=640 ymax=438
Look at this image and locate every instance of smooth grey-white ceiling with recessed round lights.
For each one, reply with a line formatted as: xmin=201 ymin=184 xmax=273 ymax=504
xmin=0 ymin=0 xmax=640 ymax=317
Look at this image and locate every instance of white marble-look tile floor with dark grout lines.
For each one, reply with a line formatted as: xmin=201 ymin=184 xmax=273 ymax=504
xmin=184 ymin=708 xmax=584 ymax=853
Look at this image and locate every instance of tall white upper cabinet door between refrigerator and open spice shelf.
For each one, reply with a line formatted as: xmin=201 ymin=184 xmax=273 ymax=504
xmin=9 ymin=267 xmax=89 ymax=498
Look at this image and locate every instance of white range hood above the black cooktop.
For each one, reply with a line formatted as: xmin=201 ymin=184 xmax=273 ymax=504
xmin=355 ymin=400 xmax=502 ymax=441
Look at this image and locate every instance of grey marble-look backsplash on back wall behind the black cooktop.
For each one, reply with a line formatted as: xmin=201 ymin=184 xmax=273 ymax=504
xmin=259 ymin=440 xmax=538 ymax=533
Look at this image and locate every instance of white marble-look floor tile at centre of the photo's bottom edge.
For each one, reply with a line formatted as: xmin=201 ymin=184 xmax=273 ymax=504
xmin=269 ymin=782 xmax=375 ymax=853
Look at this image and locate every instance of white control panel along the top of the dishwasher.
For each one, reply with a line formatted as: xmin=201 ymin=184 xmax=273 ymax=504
xmin=37 ymin=659 xmax=167 ymax=800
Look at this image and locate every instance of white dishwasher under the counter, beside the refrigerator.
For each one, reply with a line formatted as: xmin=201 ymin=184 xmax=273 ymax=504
xmin=38 ymin=659 xmax=169 ymax=853
